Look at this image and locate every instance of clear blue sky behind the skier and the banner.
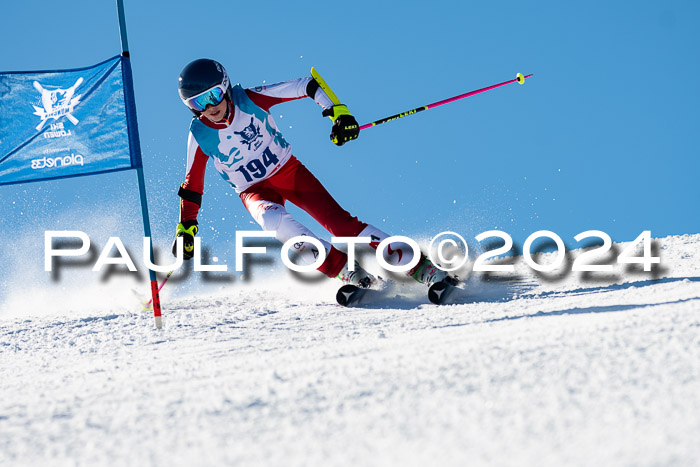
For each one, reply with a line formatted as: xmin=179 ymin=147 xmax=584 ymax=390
xmin=0 ymin=0 xmax=700 ymax=296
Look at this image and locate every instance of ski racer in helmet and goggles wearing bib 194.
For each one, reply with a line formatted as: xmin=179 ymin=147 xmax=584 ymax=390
xmin=173 ymin=59 xmax=447 ymax=288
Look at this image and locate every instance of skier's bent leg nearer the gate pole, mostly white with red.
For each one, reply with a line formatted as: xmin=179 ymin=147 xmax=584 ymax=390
xmin=241 ymin=187 xmax=348 ymax=277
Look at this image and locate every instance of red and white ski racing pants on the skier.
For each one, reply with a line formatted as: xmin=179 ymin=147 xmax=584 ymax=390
xmin=240 ymin=156 xmax=413 ymax=277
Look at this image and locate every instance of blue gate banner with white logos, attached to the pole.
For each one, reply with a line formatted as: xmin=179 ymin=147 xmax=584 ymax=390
xmin=0 ymin=56 xmax=141 ymax=185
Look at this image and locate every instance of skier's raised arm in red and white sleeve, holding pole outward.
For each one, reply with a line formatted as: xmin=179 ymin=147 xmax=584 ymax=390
xmin=245 ymin=77 xmax=333 ymax=112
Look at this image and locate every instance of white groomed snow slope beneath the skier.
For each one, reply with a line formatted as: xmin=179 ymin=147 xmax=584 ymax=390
xmin=0 ymin=234 xmax=700 ymax=466
